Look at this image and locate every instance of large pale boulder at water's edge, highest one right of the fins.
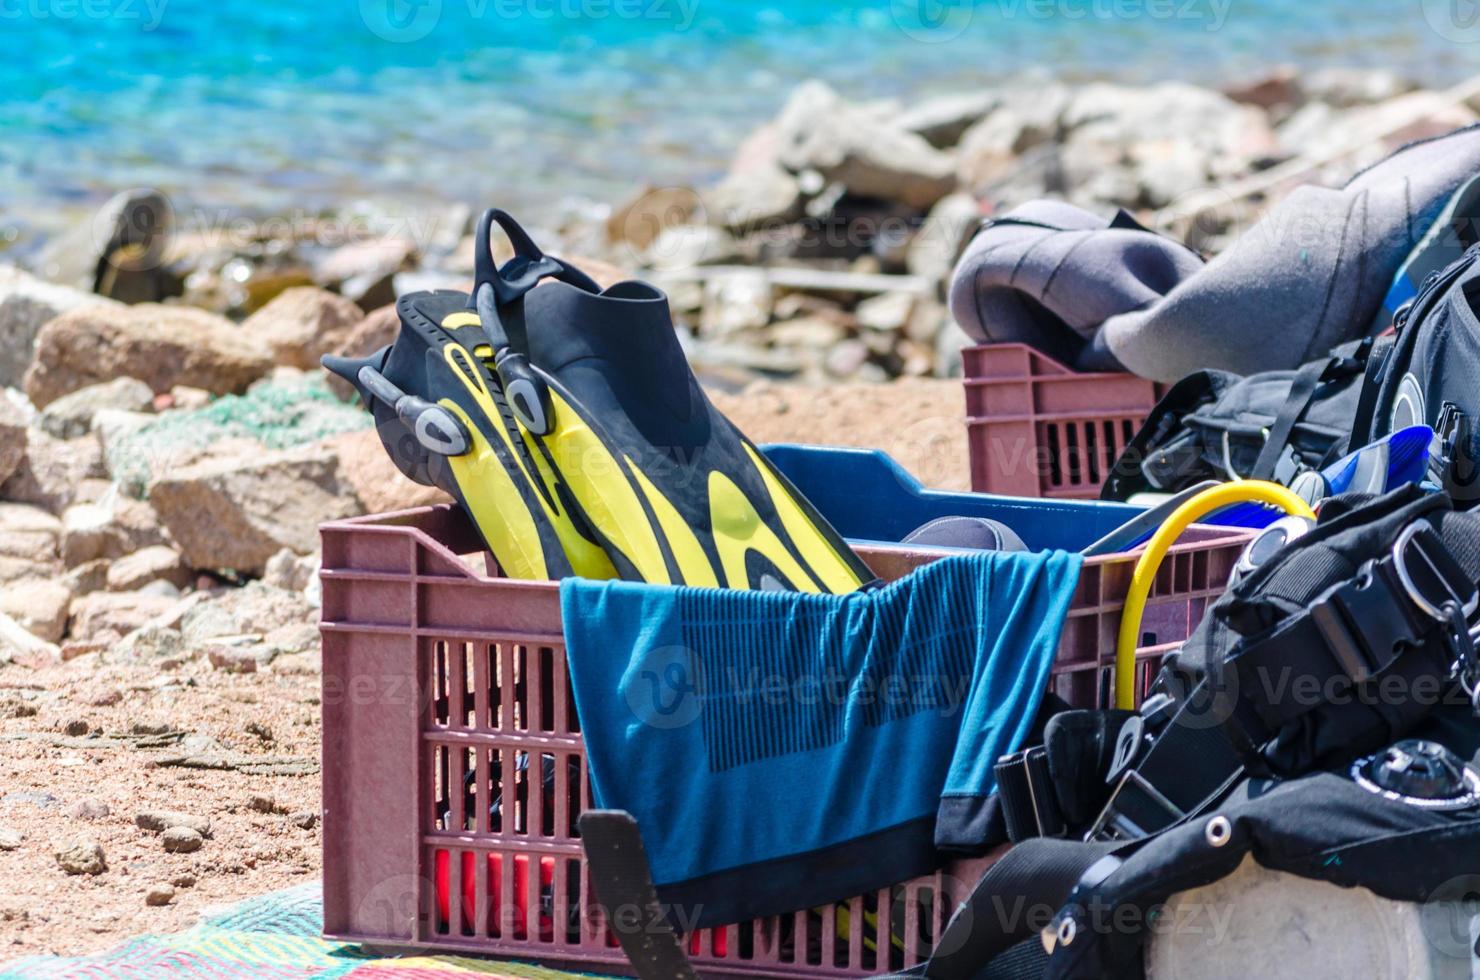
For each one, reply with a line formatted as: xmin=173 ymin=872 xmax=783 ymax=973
xmin=776 ymin=81 xmax=956 ymax=210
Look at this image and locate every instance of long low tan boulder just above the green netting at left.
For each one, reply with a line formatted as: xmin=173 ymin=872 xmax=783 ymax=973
xmin=25 ymin=303 xmax=272 ymax=409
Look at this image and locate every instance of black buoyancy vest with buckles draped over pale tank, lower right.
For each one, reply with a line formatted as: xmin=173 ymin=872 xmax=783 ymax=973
xmin=893 ymin=486 xmax=1480 ymax=980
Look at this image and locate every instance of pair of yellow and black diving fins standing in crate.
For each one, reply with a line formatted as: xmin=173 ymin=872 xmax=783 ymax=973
xmin=323 ymin=209 xmax=873 ymax=594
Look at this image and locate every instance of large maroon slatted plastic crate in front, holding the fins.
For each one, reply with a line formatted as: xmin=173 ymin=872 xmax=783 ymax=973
xmin=321 ymin=506 xmax=1248 ymax=977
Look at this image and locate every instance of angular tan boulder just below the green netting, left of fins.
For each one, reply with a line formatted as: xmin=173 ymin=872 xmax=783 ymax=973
xmin=149 ymin=446 xmax=363 ymax=574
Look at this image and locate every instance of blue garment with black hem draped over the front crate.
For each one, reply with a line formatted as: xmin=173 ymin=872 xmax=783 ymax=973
xmin=561 ymin=552 xmax=1082 ymax=927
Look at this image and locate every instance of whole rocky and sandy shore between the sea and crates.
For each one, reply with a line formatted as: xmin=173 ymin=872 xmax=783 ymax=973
xmin=0 ymin=71 xmax=1480 ymax=952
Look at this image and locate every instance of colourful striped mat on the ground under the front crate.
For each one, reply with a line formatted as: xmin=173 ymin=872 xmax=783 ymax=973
xmin=0 ymin=884 xmax=603 ymax=980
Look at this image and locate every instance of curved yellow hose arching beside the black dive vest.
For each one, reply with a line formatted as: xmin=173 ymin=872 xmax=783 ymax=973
xmin=1114 ymin=480 xmax=1316 ymax=711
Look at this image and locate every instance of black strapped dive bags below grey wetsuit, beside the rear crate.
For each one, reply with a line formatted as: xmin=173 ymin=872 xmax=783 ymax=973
xmin=1101 ymin=246 xmax=1480 ymax=508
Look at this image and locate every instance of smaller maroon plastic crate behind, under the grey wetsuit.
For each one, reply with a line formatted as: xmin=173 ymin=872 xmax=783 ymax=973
xmin=962 ymin=343 xmax=1166 ymax=500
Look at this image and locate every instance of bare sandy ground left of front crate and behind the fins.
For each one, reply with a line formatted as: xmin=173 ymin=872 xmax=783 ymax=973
xmin=0 ymin=380 xmax=966 ymax=962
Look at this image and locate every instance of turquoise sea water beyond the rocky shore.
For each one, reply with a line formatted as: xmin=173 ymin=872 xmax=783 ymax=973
xmin=0 ymin=0 xmax=1480 ymax=232
